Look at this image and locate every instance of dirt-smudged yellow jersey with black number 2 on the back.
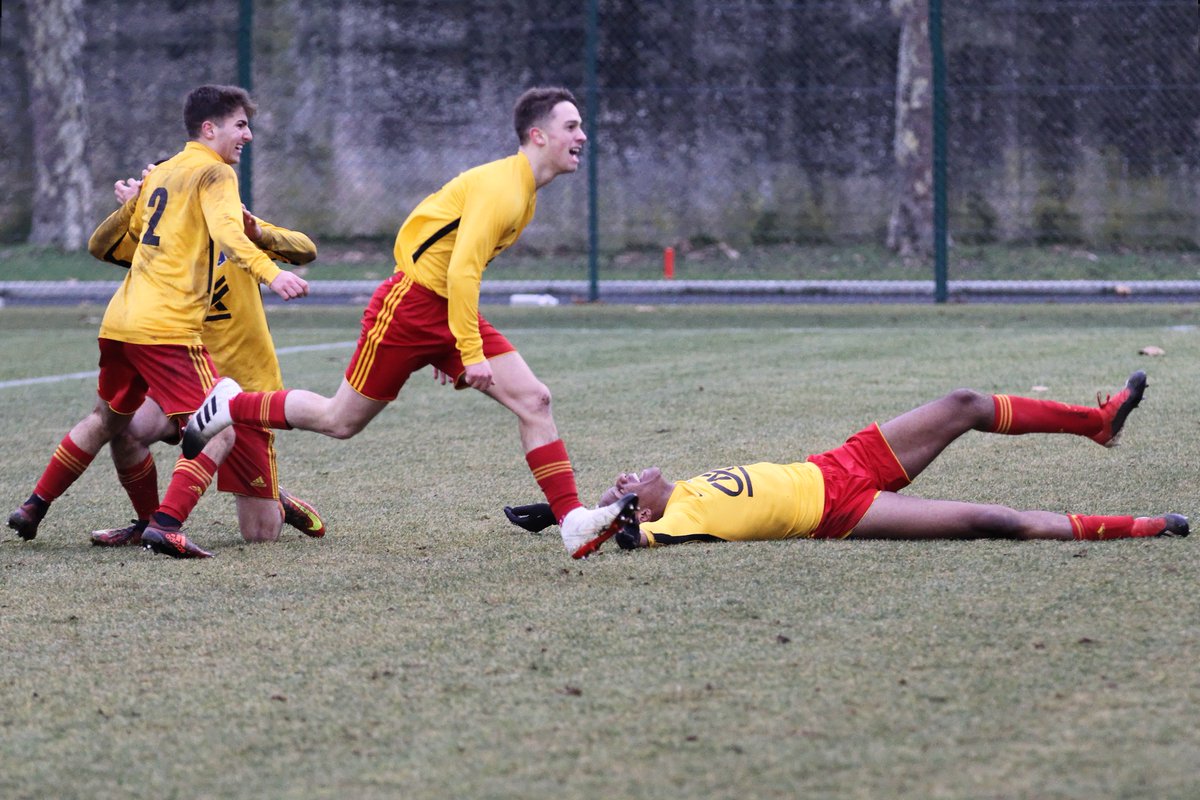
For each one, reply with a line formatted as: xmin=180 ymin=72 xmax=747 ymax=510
xmin=100 ymin=142 xmax=281 ymax=344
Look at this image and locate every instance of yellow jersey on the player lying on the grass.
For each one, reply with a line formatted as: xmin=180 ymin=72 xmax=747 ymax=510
xmin=641 ymin=462 xmax=824 ymax=547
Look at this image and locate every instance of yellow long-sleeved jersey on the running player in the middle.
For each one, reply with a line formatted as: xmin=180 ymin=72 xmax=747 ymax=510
xmin=394 ymin=152 xmax=538 ymax=366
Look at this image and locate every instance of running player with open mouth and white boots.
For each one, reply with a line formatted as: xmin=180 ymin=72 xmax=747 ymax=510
xmin=184 ymin=89 xmax=638 ymax=558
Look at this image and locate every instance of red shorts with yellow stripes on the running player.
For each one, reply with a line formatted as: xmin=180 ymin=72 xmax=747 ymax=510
xmin=346 ymin=272 xmax=516 ymax=403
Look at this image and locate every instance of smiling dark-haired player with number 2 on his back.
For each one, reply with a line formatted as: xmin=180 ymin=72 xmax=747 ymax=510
xmin=8 ymin=85 xmax=308 ymax=558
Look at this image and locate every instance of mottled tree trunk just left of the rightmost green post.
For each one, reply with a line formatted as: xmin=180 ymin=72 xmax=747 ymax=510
xmin=887 ymin=0 xmax=934 ymax=255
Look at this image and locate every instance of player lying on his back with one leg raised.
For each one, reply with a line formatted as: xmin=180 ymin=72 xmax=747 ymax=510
xmin=504 ymin=372 xmax=1188 ymax=549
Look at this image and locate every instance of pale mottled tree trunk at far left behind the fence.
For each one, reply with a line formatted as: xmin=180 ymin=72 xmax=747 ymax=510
xmin=25 ymin=0 xmax=91 ymax=249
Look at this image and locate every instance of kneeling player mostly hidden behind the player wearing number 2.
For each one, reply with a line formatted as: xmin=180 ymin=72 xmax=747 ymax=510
xmin=88 ymin=164 xmax=325 ymax=547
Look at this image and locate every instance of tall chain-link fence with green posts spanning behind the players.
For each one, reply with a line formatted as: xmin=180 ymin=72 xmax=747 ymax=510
xmin=0 ymin=0 xmax=1200 ymax=279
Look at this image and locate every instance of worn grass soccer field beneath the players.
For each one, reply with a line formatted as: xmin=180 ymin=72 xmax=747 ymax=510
xmin=0 ymin=303 xmax=1200 ymax=799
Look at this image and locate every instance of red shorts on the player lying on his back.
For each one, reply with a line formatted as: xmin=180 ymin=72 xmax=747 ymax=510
xmin=809 ymin=423 xmax=911 ymax=539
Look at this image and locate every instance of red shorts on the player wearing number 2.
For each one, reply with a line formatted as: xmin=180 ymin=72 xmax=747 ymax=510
xmin=96 ymin=338 xmax=217 ymax=416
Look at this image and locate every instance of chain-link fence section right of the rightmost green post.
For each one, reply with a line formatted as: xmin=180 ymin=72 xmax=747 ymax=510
xmin=944 ymin=0 xmax=1200 ymax=257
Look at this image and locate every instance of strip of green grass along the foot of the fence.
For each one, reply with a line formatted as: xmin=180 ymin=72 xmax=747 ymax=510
xmin=7 ymin=240 xmax=1200 ymax=281
